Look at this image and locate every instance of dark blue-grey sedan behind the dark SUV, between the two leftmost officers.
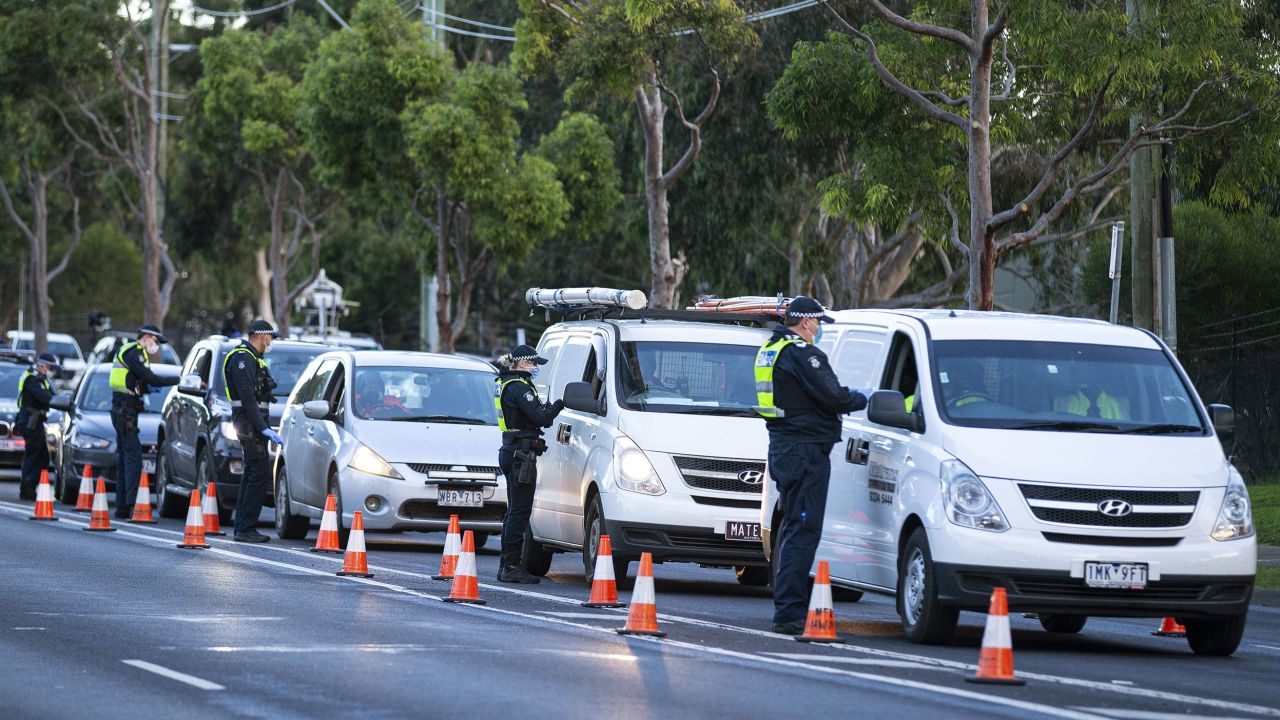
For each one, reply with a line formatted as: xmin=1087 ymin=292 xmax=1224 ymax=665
xmin=50 ymin=363 xmax=179 ymax=505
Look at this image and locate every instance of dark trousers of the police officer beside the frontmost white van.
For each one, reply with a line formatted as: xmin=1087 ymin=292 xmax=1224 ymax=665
xmin=769 ymin=438 xmax=832 ymax=624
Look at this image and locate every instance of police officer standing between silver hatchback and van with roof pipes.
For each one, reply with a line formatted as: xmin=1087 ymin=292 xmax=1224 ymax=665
xmin=493 ymin=345 xmax=564 ymax=584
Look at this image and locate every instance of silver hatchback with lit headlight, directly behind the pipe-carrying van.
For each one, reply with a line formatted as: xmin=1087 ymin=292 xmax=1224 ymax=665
xmin=275 ymin=350 xmax=507 ymax=546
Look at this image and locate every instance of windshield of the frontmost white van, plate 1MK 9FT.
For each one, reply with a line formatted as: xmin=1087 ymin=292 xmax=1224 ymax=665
xmin=933 ymin=341 xmax=1208 ymax=434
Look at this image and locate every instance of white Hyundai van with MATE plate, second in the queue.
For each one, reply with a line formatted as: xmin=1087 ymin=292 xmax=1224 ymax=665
xmin=525 ymin=304 xmax=769 ymax=585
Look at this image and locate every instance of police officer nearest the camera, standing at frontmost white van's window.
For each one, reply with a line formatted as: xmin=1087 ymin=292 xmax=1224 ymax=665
xmin=755 ymin=295 xmax=867 ymax=635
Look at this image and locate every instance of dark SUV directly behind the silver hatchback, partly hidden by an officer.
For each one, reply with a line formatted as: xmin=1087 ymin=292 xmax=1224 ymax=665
xmin=155 ymin=336 xmax=329 ymax=515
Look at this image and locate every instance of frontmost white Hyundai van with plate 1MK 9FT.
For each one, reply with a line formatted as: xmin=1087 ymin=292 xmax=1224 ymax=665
xmin=762 ymin=310 xmax=1257 ymax=655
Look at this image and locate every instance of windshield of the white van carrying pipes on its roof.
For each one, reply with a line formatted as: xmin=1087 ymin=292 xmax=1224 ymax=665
xmin=618 ymin=342 xmax=759 ymax=418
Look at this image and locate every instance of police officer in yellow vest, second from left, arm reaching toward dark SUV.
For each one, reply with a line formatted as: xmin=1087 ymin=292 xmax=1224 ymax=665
xmin=109 ymin=325 xmax=178 ymax=518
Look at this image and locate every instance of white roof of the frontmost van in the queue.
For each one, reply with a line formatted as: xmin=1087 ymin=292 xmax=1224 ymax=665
xmin=829 ymin=309 xmax=1160 ymax=348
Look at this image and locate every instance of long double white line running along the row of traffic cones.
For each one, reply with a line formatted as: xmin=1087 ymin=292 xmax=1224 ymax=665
xmin=0 ymin=501 xmax=1280 ymax=717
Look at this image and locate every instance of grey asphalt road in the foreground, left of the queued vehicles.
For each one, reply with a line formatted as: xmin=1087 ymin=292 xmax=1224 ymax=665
xmin=0 ymin=483 xmax=1280 ymax=720
